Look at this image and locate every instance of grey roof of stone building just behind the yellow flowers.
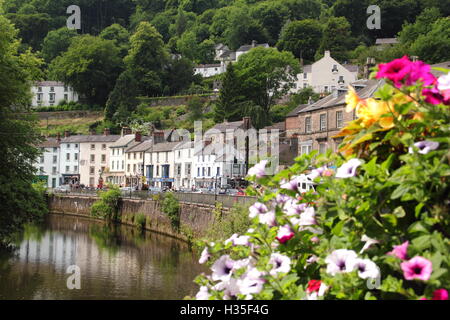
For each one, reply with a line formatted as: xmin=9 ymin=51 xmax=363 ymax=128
xmin=298 ymin=80 xmax=385 ymax=113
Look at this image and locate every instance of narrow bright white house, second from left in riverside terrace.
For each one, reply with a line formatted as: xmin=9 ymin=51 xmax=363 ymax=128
xmin=59 ymin=132 xmax=80 ymax=185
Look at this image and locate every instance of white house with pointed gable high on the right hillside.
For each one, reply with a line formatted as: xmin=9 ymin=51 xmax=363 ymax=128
xmin=291 ymin=51 xmax=359 ymax=93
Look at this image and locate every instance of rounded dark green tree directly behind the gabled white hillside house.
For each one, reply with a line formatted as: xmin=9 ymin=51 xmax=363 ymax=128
xmin=277 ymin=19 xmax=322 ymax=62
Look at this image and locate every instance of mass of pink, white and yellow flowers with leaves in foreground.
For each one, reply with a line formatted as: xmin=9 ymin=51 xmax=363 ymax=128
xmin=192 ymin=57 xmax=450 ymax=300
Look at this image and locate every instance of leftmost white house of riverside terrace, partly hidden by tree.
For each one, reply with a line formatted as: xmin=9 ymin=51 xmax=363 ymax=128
xmin=34 ymin=138 xmax=60 ymax=188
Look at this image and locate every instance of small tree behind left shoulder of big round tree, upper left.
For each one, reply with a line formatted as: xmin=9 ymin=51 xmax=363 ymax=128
xmin=42 ymin=27 xmax=77 ymax=63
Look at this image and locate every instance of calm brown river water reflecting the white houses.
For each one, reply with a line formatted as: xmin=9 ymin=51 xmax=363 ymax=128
xmin=0 ymin=214 xmax=205 ymax=299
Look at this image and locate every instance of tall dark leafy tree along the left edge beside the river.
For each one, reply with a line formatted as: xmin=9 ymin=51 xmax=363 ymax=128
xmin=0 ymin=13 xmax=47 ymax=243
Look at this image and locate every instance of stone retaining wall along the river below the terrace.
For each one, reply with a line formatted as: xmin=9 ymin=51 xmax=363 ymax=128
xmin=48 ymin=195 xmax=223 ymax=240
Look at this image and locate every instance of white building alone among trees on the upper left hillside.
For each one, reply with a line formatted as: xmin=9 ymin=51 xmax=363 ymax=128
xmin=31 ymin=81 xmax=78 ymax=107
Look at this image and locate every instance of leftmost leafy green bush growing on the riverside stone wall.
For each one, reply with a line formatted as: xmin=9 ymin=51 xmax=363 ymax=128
xmin=91 ymin=185 xmax=121 ymax=221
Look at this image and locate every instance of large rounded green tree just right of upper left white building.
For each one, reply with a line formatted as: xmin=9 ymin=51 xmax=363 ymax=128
xmin=50 ymin=35 xmax=123 ymax=105
